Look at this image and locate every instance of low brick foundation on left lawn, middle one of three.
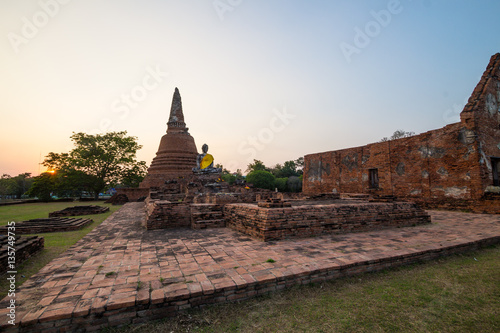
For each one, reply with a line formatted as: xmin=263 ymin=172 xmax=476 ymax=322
xmin=0 ymin=217 xmax=93 ymax=235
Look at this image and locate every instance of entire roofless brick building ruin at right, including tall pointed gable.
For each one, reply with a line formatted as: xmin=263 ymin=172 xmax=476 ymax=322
xmin=303 ymin=53 xmax=500 ymax=213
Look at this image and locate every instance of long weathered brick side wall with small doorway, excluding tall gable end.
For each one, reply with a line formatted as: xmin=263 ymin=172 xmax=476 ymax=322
xmin=304 ymin=124 xmax=480 ymax=199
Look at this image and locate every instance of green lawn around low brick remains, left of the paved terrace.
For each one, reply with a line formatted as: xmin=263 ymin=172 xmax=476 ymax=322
xmin=0 ymin=201 xmax=121 ymax=299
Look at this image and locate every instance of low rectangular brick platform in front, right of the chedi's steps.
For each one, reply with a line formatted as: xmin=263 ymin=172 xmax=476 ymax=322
xmin=224 ymin=202 xmax=431 ymax=241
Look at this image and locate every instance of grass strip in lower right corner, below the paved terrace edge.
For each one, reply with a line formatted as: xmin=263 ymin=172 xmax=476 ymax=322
xmin=108 ymin=246 xmax=500 ymax=333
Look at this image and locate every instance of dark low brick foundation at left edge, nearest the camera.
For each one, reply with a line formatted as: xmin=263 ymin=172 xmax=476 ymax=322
xmin=0 ymin=235 xmax=44 ymax=275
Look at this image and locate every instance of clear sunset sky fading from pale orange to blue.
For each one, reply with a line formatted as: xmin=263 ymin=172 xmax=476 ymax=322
xmin=0 ymin=0 xmax=500 ymax=176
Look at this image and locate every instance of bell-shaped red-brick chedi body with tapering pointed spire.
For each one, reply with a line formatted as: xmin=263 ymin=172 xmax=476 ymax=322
xmin=140 ymin=88 xmax=198 ymax=188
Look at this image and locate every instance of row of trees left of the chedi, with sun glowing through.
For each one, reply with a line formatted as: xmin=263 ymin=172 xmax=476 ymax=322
xmin=0 ymin=131 xmax=147 ymax=201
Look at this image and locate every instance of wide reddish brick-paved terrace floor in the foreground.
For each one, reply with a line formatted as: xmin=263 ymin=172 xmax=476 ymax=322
xmin=0 ymin=202 xmax=500 ymax=331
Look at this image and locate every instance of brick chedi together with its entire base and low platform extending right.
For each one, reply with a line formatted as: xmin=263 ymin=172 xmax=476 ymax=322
xmin=134 ymin=88 xmax=430 ymax=241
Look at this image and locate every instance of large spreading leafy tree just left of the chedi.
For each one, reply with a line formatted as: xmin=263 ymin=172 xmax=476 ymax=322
xmin=42 ymin=131 xmax=146 ymax=199
